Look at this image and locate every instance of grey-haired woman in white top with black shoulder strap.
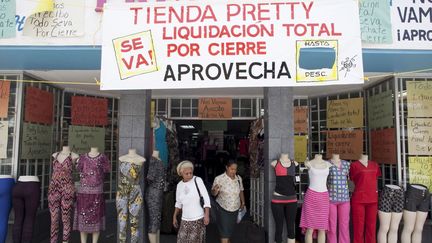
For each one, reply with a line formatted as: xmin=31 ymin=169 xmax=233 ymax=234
xmin=173 ymin=160 xmax=210 ymax=243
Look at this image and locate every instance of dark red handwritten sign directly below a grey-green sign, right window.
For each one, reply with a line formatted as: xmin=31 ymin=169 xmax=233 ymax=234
xmin=371 ymin=128 xmax=397 ymax=164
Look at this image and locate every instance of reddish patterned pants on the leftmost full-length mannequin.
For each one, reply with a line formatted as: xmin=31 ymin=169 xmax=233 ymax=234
xmin=48 ymin=185 xmax=75 ymax=243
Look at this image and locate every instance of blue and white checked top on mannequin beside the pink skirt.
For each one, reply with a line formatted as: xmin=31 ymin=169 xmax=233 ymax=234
xmin=327 ymin=160 xmax=350 ymax=203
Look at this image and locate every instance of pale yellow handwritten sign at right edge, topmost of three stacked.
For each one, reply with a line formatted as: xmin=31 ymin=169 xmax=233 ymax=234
xmin=406 ymin=81 xmax=432 ymax=117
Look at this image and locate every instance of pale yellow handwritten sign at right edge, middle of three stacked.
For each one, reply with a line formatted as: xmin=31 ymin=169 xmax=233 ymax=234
xmin=407 ymin=118 xmax=432 ymax=155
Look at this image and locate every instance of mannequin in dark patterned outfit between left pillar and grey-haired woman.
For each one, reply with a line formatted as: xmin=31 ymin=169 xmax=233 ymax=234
xmin=146 ymin=150 xmax=166 ymax=243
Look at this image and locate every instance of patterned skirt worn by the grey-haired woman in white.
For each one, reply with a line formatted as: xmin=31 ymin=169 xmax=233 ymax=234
xmin=177 ymin=219 xmax=205 ymax=243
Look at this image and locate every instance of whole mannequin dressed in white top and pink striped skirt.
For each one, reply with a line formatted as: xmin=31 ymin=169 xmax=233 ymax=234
xmin=300 ymin=154 xmax=332 ymax=243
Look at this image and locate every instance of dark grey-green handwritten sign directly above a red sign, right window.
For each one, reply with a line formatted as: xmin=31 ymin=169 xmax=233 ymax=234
xmin=367 ymin=90 xmax=394 ymax=129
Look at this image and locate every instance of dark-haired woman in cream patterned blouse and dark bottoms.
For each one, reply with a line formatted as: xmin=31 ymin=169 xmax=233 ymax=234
xmin=212 ymin=161 xmax=245 ymax=243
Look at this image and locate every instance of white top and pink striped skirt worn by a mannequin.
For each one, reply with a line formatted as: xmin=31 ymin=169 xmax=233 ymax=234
xmin=300 ymin=167 xmax=330 ymax=233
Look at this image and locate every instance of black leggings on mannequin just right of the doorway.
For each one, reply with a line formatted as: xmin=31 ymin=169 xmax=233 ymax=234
xmin=271 ymin=202 xmax=297 ymax=243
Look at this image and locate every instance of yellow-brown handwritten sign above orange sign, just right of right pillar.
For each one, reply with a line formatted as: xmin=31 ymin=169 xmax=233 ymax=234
xmin=327 ymin=98 xmax=363 ymax=128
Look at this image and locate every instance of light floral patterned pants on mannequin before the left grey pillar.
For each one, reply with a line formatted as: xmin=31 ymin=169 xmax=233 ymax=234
xmin=116 ymin=184 xmax=143 ymax=243
